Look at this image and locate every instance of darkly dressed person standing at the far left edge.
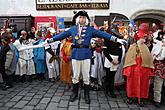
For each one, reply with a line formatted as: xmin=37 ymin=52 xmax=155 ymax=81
xmin=0 ymin=33 xmax=16 ymax=90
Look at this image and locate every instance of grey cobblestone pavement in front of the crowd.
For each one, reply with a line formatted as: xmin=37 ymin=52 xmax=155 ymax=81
xmin=0 ymin=81 xmax=165 ymax=110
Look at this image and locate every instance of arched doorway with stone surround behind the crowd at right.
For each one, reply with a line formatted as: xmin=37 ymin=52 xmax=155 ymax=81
xmin=130 ymin=9 xmax=165 ymax=29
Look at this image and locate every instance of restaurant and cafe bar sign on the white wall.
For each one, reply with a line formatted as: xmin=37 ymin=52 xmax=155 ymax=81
xmin=36 ymin=0 xmax=110 ymax=10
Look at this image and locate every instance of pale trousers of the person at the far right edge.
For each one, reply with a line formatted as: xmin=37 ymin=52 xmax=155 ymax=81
xmin=154 ymin=76 xmax=165 ymax=102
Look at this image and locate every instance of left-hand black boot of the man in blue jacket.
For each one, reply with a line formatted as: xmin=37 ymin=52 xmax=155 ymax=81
xmin=70 ymin=83 xmax=79 ymax=102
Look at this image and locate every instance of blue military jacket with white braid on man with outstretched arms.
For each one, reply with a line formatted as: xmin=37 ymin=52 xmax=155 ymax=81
xmin=53 ymin=25 xmax=116 ymax=60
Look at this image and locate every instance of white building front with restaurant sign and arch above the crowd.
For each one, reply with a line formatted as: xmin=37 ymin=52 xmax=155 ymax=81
xmin=0 ymin=0 xmax=165 ymax=29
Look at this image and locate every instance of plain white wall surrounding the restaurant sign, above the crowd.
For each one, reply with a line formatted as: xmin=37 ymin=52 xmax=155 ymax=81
xmin=0 ymin=0 xmax=165 ymax=18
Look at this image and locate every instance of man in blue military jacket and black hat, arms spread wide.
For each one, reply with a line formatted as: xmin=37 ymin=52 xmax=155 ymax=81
xmin=47 ymin=11 xmax=125 ymax=104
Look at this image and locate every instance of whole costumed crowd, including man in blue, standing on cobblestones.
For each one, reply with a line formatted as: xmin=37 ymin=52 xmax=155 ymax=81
xmin=0 ymin=11 xmax=165 ymax=107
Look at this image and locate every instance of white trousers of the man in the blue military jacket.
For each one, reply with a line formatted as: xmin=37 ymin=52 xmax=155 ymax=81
xmin=72 ymin=59 xmax=90 ymax=85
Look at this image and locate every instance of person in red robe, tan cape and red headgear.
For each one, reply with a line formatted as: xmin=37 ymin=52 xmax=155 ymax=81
xmin=124 ymin=23 xmax=154 ymax=103
